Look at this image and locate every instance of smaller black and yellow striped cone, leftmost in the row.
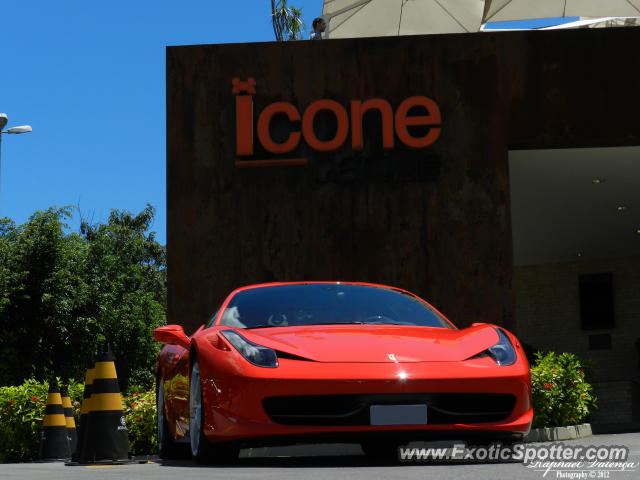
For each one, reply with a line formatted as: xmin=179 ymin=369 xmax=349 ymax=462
xmin=40 ymin=379 xmax=71 ymax=460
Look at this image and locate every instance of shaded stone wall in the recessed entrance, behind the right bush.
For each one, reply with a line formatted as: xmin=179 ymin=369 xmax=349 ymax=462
xmin=514 ymin=258 xmax=640 ymax=382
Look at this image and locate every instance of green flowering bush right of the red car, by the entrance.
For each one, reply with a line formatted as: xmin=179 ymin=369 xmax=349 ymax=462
xmin=531 ymin=352 xmax=596 ymax=428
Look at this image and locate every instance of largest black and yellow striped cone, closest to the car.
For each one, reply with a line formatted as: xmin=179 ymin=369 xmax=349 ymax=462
xmin=80 ymin=345 xmax=129 ymax=463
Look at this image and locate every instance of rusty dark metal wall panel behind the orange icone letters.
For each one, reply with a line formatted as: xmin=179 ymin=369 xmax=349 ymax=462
xmin=167 ymin=34 xmax=513 ymax=329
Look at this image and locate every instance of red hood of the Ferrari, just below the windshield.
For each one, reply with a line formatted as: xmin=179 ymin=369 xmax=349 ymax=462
xmin=241 ymin=324 xmax=499 ymax=363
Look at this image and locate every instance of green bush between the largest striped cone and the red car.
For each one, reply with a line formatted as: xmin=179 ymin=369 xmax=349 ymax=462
xmin=122 ymin=387 xmax=158 ymax=455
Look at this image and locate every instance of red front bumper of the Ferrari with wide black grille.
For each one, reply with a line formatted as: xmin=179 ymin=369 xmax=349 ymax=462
xmin=201 ymin=357 xmax=533 ymax=441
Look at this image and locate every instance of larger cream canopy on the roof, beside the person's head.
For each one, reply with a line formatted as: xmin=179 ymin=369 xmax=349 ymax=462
xmin=322 ymin=0 xmax=484 ymax=38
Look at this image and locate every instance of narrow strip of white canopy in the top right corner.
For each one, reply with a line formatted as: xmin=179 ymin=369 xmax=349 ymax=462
xmin=482 ymin=0 xmax=640 ymax=23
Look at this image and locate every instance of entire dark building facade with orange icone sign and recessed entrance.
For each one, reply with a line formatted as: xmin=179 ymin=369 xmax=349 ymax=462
xmin=167 ymin=28 xmax=640 ymax=424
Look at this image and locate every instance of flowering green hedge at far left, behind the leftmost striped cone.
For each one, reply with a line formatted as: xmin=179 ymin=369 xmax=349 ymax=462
xmin=0 ymin=379 xmax=84 ymax=462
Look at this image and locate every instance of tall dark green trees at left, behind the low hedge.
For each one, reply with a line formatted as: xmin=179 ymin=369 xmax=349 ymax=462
xmin=0 ymin=205 xmax=166 ymax=389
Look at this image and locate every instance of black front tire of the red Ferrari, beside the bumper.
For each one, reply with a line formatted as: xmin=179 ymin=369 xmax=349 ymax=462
xmin=189 ymin=358 xmax=239 ymax=463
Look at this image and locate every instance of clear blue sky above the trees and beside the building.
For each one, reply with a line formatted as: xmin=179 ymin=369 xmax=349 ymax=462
xmin=0 ymin=0 xmax=568 ymax=243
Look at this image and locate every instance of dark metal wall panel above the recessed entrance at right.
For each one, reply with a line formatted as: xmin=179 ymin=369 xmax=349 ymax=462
xmin=498 ymin=27 xmax=640 ymax=149
